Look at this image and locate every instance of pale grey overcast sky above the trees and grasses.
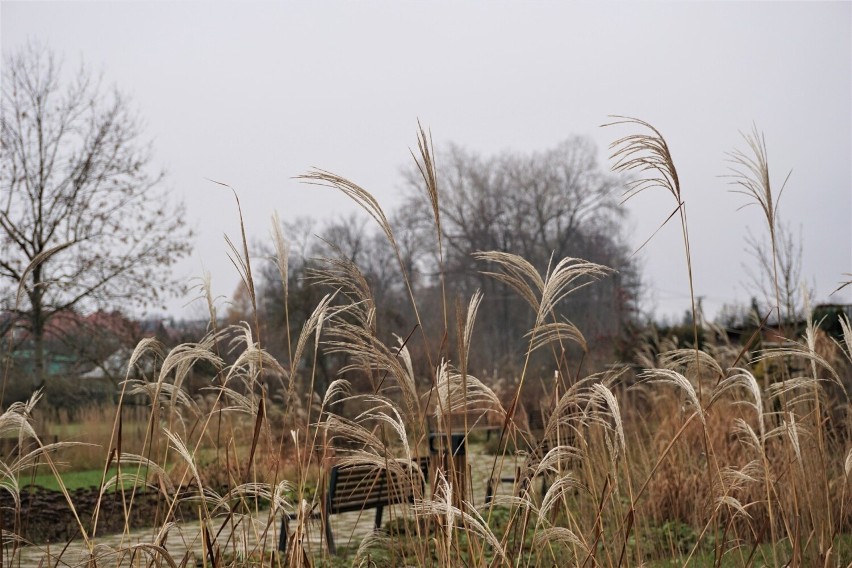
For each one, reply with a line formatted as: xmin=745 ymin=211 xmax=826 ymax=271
xmin=0 ymin=1 xmax=852 ymax=324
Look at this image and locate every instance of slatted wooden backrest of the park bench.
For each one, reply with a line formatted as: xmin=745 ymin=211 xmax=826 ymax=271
xmin=326 ymin=457 xmax=428 ymax=514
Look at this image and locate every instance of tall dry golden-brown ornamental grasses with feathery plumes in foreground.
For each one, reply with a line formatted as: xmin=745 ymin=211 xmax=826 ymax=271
xmin=0 ymin=118 xmax=852 ymax=566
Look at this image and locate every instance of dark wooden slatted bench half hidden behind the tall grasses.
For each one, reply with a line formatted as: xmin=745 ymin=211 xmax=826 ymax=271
xmin=278 ymin=457 xmax=429 ymax=556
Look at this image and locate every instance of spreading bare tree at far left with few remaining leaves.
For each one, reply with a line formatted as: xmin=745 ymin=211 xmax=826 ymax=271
xmin=0 ymin=45 xmax=191 ymax=384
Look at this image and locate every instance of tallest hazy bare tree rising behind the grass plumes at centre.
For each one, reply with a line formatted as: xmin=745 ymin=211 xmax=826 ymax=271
xmin=403 ymin=137 xmax=638 ymax=365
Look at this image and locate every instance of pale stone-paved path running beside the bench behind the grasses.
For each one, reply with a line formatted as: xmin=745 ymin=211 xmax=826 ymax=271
xmin=6 ymin=451 xmax=515 ymax=568
